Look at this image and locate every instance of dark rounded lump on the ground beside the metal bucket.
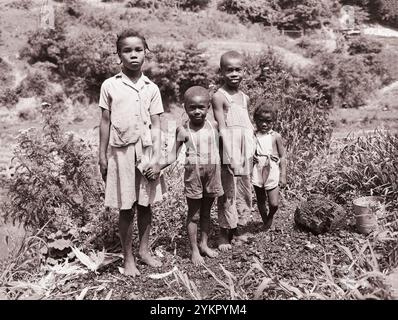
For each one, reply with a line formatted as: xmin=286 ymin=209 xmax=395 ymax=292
xmin=294 ymin=195 xmax=346 ymax=235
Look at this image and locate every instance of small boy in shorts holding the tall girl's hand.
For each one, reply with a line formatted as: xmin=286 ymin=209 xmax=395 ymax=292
xmin=152 ymin=86 xmax=223 ymax=265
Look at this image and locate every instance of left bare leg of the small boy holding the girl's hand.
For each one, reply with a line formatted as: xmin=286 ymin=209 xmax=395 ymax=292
xmin=187 ymin=198 xmax=205 ymax=266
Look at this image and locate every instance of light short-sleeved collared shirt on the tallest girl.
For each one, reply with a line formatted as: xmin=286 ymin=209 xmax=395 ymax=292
xmin=99 ymin=72 xmax=164 ymax=147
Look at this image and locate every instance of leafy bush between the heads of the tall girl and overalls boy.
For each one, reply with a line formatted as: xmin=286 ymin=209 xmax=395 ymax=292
xmin=145 ymin=43 xmax=209 ymax=106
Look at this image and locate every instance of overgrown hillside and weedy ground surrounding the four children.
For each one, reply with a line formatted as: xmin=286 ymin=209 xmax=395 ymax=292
xmin=0 ymin=0 xmax=398 ymax=299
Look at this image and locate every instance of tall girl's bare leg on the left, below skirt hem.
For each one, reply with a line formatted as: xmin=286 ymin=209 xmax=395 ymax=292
xmin=119 ymin=208 xmax=140 ymax=277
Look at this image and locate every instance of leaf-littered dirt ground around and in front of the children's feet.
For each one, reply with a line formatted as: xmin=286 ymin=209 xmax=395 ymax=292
xmin=12 ymin=201 xmax=374 ymax=300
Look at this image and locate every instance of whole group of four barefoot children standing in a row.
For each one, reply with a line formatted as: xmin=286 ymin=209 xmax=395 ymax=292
xmin=99 ymin=30 xmax=286 ymax=276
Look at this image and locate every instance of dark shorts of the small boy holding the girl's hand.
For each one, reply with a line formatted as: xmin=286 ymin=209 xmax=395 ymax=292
xmin=184 ymin=164 xmax=224 ymax=199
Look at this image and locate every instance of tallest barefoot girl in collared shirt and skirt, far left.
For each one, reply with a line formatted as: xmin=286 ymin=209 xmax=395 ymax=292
xmin=99 ymin=30 xmax=163 ymax=276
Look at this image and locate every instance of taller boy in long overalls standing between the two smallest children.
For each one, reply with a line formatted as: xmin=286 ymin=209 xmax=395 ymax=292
xmin=212 ymin=51 xmax=254 ymax=251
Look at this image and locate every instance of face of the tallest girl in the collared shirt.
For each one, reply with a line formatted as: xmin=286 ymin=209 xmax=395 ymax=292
xmin=119 ymin=37 xmax=145 ymax=71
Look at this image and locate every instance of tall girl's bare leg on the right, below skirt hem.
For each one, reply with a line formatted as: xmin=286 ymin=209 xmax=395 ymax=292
xmin=137 ymin=205 xmax=162 ymax=268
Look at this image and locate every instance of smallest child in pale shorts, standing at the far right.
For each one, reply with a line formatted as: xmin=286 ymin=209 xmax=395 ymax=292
xmin=252 ymin=104 xmax=286 ymax=230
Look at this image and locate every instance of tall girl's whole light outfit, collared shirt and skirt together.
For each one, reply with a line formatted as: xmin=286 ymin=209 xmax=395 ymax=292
xmin=99 ymin=72 xmax=165 ymax=209
